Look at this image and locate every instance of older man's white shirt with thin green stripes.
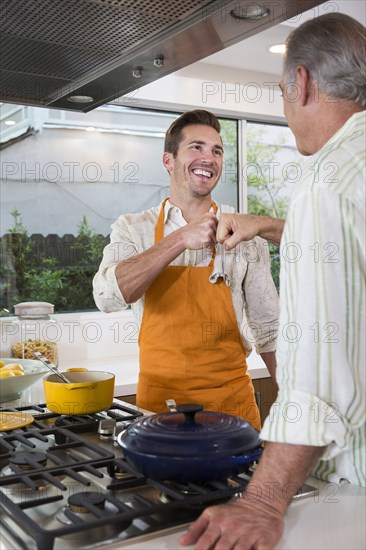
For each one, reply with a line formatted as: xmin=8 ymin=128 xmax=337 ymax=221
xmin=261 ymin=112 xmax=366 ymax=486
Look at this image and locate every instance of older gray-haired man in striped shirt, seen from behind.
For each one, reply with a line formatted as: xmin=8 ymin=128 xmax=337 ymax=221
xmin=180 ymin=13 xmax=366 ymax=550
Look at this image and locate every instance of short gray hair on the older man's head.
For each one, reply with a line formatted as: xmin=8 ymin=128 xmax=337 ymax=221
xmin=284 ymin=13 xmax=366 ymax=107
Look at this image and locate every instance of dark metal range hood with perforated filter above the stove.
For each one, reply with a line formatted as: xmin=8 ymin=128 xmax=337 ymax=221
xmin=0 ymin=0 xmax=323 ymax=112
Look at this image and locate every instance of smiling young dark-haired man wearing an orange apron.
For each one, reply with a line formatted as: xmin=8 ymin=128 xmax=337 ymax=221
xmin=94 ymin=110 xmax=278 ymax=429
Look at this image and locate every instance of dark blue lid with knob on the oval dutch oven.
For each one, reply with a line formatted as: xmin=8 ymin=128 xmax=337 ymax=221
xmin=121 ymin=405 xmax=261 ymax=457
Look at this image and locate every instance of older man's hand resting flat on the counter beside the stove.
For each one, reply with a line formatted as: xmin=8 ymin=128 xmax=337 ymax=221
xmin=179 ymin=498 xmax=284 ymax=550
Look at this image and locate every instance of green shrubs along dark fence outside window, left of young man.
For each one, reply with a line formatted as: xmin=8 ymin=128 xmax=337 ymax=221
xmin=0 ymin=210 xmax=106 ymax=315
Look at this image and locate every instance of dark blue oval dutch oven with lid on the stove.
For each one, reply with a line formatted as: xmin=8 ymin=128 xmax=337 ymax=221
xmin=118 ymin=405 xmax=262 ymax=483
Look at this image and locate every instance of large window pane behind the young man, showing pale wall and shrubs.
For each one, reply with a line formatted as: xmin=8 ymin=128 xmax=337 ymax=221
xmin=0 ymin=104 xmax=238 ymax=313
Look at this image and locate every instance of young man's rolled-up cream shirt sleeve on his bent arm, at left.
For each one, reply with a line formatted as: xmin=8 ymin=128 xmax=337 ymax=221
xmin=93 ymin=216 xmax=142 ymax=313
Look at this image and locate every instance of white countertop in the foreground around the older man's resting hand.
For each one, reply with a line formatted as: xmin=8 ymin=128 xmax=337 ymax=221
xmin=108 ymin=478 xmax=366 ymax=550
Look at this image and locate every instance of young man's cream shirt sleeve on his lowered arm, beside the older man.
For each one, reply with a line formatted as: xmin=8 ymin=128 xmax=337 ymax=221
xmin=241 ymin=237 xmax=279 ymax=353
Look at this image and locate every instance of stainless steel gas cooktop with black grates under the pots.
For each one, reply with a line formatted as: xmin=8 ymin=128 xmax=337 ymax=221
xmin=0 ymin=400 xmax=251 ymax=550
